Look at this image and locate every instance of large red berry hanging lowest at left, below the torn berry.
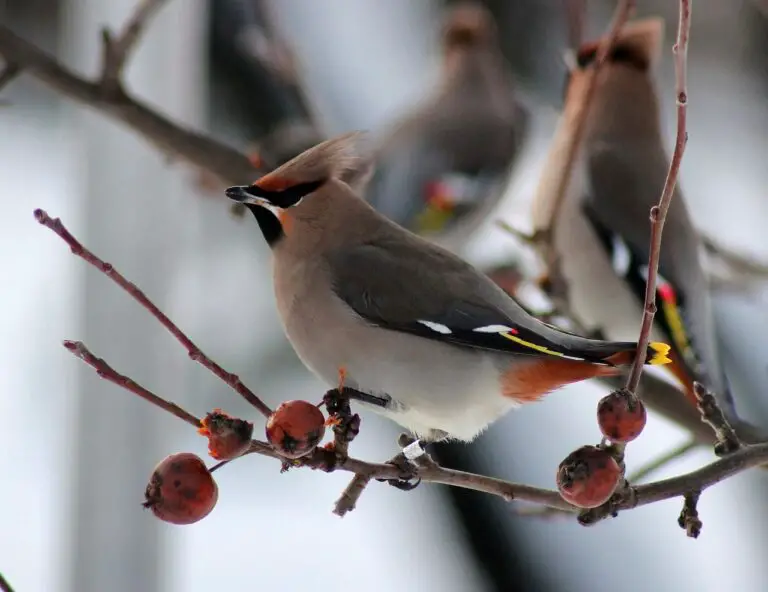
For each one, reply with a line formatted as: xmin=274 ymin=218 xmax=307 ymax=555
xmin=143 ymin=452 xmax=219 ymax=524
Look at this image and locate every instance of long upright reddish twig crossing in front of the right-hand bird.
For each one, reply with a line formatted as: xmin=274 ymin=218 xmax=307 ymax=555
xmin=627 ymin=0 xmax=691 ymax=393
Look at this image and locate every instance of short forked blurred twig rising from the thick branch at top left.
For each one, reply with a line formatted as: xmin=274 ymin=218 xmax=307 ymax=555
xmin=101 ymin=0 xmax=166 ymax=92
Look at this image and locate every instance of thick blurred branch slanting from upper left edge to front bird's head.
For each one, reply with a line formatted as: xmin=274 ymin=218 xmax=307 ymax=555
xmin=0 ymin=24 xmax=259 ymax=184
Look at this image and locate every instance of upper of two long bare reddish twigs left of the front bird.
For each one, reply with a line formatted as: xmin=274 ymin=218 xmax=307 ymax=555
xmin=35 ymin=209 xmax=272 ymax=417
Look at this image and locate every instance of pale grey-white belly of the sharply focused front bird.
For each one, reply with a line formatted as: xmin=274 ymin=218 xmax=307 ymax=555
xmin=285 ymin=296 xmax=516 ymax=440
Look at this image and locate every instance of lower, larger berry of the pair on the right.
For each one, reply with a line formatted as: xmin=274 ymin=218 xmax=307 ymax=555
xmin=557 ymin=446 xmax=621 ymax=508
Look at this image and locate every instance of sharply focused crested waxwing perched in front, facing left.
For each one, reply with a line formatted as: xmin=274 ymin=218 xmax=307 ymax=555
xmin=226 ymin=134 xmax=669 ymax=442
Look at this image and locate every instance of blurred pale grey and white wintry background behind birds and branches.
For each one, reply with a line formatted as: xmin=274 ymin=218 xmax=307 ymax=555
xmin=0 ymin=0 xmax=768 ymax=592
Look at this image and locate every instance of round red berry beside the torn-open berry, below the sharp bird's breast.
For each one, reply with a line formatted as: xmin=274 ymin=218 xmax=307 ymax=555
xmin=266 ymin=401 xmax=325 ymax=458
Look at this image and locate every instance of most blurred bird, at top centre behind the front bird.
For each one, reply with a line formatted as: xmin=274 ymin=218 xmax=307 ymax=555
xmin=367 ymin=2 xmax=529 ymax=234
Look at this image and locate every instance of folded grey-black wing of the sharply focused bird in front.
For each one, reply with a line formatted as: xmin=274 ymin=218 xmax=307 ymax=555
xmin=329 ymin=239 xmax=636 ymax=363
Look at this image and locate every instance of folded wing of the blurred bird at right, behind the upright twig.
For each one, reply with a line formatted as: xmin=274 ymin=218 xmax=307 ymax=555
xmin=585 ymin=142 xmax=732 ymax=398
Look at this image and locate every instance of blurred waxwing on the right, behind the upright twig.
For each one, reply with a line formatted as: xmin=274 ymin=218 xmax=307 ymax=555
xmin=533 ymin=18 xmax=759 ymax=440
